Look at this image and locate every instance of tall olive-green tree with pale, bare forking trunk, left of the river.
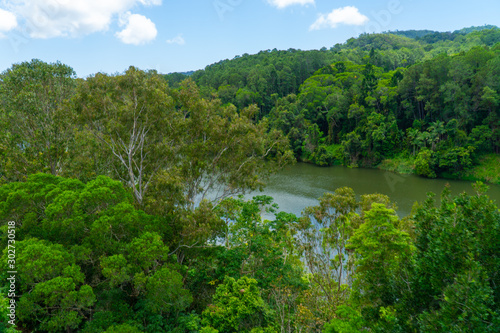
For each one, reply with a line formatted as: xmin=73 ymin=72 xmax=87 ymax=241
xmin=73 ymin=67 xmax=179 ymax=204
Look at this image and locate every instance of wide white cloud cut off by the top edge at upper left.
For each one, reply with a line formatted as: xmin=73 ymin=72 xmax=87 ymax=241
xmin=3 ymin=0 xmax=161 ymax=38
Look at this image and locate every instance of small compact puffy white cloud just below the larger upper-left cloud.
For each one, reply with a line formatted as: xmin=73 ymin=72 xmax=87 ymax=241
xmin=115 ymin=12 xmax=158 ymax=45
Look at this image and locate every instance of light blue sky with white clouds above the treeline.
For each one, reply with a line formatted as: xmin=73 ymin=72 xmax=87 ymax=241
xmin=0 ymin=0 xmax=500 ymax=78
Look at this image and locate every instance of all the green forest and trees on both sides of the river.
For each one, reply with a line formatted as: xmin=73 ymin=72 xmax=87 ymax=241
xmin=0 ymin=27 xmax=500 ymax=333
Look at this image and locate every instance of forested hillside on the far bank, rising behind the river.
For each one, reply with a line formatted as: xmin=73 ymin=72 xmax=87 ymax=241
xmin=167 ymin=26 xmax=500 ymax=182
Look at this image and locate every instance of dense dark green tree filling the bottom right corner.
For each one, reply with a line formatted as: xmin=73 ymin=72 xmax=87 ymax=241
xmin=407 ymin=183 xmax=500 ymax=332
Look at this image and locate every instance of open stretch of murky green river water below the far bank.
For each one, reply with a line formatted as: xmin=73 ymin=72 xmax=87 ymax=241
xmin=249 ymin=163 xmax=500 ymax=217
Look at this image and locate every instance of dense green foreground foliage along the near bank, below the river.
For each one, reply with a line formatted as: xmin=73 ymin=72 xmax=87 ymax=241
xmin=0 ymin=174 xmax=500 ymax=332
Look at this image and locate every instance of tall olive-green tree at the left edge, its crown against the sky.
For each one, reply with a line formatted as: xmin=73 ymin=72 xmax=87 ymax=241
xmin=0 ymin=59 xmax=76 ymax=180
